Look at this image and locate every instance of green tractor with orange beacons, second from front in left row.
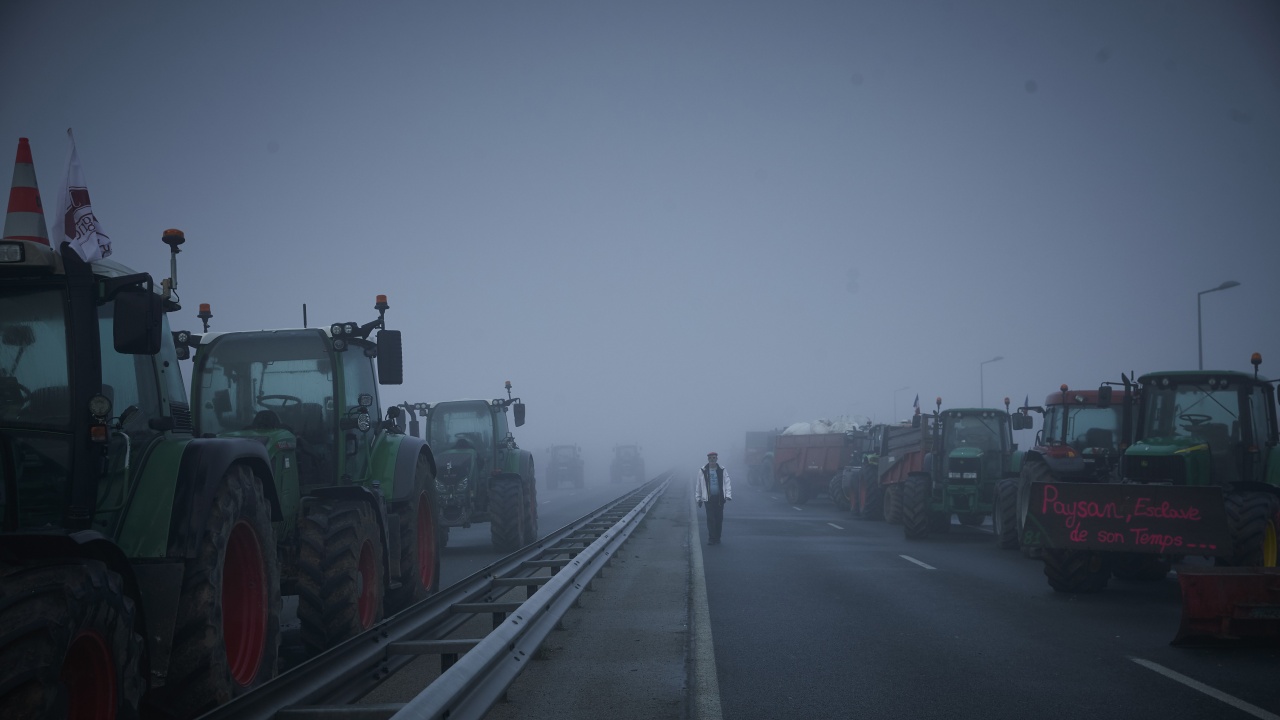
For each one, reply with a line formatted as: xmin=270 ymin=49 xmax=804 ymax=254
xmin=177 ymin=295 xmax=440 ymax=653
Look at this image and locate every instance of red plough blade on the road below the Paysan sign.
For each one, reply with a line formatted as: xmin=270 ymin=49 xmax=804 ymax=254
xmin=1170 ymin=565 xmax=1280 ymax=646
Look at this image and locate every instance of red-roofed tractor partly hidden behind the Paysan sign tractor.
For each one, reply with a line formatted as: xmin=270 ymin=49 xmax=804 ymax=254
xmin=992 ymin=383 xmax=1128 ymax=548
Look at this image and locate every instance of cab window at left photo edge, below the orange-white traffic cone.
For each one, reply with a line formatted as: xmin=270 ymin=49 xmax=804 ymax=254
xmin=0 ymin=290 xmax=70 ymax=429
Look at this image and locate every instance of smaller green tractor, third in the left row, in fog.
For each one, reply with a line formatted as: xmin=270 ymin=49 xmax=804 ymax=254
xmin=410 ymin=380 xmax=538 ymax=552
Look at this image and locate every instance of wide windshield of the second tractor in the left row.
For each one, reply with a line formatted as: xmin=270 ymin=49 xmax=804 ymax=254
xmin=192 ymin=331 xmax=334 ymax=435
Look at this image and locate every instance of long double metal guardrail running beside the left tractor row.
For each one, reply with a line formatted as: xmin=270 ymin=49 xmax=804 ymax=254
xmin=201 ymin=473 xmax=671 ymax=720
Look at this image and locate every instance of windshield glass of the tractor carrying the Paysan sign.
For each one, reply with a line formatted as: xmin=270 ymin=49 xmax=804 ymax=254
xmin=1142 ymin=383 xmax=1240 ymax=454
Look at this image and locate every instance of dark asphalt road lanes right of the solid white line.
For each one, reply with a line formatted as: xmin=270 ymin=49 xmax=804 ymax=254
xmin=699 ymin=483 xmax=1280 ymax=720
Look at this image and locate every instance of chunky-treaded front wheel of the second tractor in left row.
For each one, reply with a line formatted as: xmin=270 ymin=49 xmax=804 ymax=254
xmin=298 ymin=498 xmax=385 ymax=655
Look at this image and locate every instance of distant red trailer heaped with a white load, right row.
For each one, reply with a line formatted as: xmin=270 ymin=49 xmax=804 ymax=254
xmin=773 ymin=430 xmax=867 ymax=505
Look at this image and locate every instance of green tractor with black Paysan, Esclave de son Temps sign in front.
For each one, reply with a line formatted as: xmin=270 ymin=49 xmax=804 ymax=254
xmin=1023 ymin=354 xmax=1280 ymax=592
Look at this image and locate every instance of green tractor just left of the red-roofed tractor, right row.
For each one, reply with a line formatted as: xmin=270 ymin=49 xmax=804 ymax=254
xmin=902 ymin=397 xmax=1030 ymax=538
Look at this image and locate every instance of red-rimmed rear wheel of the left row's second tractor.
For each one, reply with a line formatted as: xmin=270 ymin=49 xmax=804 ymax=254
xmin=385 ymin=455 xmax=440 ymax=615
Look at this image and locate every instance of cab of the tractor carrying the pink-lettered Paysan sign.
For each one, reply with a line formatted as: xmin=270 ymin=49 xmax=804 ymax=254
xmin=1123 ymin=360 xmax=1277 ymax=488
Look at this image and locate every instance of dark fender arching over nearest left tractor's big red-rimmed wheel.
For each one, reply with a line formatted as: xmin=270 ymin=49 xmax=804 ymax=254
xmin=168 ymin=438 xmax=284 ymax=559
